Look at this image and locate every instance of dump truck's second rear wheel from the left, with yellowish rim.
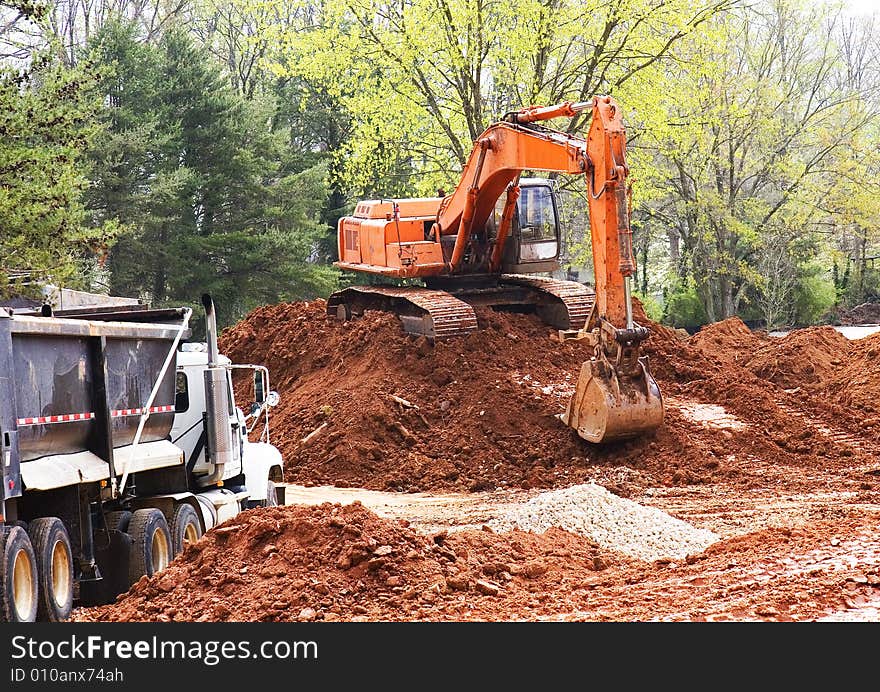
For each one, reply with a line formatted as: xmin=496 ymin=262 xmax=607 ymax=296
xmin=28 ymin=517 xmax=73 ymax=622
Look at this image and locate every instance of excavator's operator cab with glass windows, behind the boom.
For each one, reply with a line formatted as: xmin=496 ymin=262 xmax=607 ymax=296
xmin=494 ymin=178 xmax=561 ymax=274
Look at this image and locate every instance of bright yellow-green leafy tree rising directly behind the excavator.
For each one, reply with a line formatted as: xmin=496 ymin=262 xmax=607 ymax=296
xmin=266 ymin=0 xmax=732 ymax=195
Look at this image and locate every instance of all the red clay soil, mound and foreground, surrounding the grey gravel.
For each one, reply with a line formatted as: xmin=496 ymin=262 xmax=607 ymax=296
xmin=74 ymin=301 xmax=880 ymax=621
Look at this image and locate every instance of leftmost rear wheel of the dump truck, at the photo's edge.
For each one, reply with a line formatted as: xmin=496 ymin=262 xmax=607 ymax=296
xmin=0 ymin=526 xmax=38 ymax=622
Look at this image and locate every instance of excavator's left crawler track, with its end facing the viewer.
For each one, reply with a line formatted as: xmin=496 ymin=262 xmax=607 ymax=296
xmin=327 ymin=286 xmax=477 ymax=339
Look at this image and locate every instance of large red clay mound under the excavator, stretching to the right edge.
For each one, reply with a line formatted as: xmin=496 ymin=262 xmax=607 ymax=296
xmin=221 ymin=300 xmax=880 ymax=496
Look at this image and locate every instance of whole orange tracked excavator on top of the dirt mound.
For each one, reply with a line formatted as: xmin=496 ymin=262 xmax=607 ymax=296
xmin=327 ymin=96 xmax=663 ymax=442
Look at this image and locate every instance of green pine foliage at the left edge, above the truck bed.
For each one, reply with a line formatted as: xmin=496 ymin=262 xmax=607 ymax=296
xmin=0 ymin=50 xmax=116 ymax=292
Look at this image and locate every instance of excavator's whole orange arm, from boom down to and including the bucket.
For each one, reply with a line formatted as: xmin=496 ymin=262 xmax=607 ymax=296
xmin=432 ymin=96 xmax=663 ymax=442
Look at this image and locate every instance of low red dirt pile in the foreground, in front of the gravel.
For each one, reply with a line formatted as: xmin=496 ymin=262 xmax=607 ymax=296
xmin=76 ymin=503 xmax=616 ymax=621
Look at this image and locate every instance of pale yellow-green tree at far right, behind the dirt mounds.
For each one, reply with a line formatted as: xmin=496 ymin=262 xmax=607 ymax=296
xmin=640 ymin=0 xmax=878 ymax=321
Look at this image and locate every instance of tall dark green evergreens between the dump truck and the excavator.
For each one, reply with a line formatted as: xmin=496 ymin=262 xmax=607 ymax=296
xmin=84 ymin=24 xmax=335 ymax=323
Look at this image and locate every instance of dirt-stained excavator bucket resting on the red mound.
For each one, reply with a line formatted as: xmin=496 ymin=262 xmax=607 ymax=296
xmin=559 ymin=358 xmax=663 ymax=443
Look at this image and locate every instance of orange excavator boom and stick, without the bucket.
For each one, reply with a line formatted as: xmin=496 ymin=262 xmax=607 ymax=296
xmin=432 ymin=96 xmax=635 ymax=329
